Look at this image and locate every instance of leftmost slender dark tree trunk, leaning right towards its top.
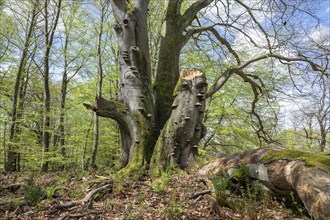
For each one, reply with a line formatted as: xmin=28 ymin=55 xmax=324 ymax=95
xmin=5 ymin=0 xmax=39 ymax=171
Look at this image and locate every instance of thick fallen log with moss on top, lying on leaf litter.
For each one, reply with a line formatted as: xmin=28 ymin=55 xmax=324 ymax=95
xmin=197 ymin=148 xmax=330 ymax=220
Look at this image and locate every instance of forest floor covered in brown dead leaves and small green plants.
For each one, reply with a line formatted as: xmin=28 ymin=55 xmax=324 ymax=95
xmin=0 ymin=168 xmax=308 ymax=220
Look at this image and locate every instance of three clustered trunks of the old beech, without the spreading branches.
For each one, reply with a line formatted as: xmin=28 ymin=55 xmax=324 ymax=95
xmin=85 ymin=0 xmax=212 ymax=175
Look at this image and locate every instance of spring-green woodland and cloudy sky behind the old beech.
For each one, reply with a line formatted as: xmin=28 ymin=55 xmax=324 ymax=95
xmin=0 ymin=0 xmax=330 ymax=172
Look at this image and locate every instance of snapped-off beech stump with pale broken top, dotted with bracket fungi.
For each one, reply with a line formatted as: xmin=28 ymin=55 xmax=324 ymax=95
xmin=151 ymin=70 xmax=207 ymax=175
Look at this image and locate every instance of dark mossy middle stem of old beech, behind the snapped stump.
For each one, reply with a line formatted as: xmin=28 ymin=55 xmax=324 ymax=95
xmin=154 ymin=0 xmax=213 ymax=129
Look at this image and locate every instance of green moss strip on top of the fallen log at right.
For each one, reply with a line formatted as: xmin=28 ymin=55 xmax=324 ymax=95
xmin=262 ymin=150 xmax=330 ymax=173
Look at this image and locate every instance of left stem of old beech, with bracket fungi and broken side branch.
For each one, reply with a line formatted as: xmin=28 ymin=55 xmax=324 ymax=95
xmin=85 ymin=0 xmax=155 ymax=176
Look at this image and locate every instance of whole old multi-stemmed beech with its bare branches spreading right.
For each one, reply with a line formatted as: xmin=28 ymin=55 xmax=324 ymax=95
xmin=84 ymin=0 xmax=327 ymax=176
